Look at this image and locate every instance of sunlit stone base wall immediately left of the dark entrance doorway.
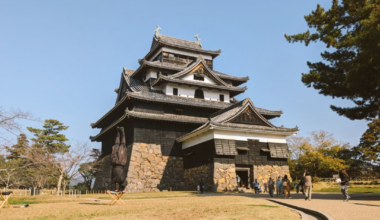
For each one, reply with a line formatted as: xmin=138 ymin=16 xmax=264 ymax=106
xmin=213 ymin=162 xmax=237 ymax=192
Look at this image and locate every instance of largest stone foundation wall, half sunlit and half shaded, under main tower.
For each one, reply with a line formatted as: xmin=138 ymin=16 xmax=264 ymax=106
xmin=126 ymin=143 xmax=185 ymax=192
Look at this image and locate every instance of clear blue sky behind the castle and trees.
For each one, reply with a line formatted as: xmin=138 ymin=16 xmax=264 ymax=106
xmin=0 ymin=0 xmax=367 ymax=147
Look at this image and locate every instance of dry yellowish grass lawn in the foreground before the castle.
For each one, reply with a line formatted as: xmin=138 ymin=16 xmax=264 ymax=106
xmin=1 ymin=192 xmax=300 ymax=220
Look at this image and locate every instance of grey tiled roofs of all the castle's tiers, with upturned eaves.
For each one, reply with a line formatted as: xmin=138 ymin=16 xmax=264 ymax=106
xmin=91 ymin=30 xmax=294 ymax=141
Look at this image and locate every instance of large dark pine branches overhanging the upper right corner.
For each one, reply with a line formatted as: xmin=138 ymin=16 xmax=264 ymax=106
xmin=285 ymin=0 xmax=380 ymax=120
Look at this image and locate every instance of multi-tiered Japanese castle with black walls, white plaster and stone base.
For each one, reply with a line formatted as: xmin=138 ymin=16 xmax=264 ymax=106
xmin=90 ymin=27 xmax=298 ymax=192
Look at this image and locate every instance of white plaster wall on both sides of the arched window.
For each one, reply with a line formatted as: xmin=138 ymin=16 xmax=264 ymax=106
xmin=162 ymin=83 xmax=230 ymax=102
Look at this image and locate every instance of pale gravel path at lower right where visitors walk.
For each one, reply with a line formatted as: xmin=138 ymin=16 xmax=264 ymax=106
xmin=254 ymin=193 xmax=380 ymax=220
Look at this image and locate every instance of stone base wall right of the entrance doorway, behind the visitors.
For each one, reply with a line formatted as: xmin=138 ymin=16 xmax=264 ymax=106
xmin=253 ymin=165 xmax=292 ymax=187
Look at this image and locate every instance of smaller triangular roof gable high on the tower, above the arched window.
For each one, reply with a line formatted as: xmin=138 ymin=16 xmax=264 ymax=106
xmin=169 ymin=56 xmax=230 ymax=86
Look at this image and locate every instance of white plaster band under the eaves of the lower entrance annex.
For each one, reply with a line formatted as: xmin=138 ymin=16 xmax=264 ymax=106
xmin=182 ymin=130 xmax=287 ymax=149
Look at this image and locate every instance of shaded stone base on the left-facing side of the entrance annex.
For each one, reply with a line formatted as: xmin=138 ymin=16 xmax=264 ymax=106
xmin=184 ymin=163 xmax=214 ymax=191
